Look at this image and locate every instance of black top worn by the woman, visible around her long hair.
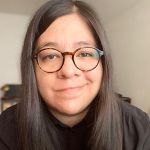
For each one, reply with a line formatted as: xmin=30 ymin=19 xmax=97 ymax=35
xmin=0 ymin=103 xmax=150 ymax=150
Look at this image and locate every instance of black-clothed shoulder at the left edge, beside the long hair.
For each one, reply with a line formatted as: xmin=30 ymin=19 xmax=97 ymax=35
xmin=0 ymin=106 xmax=17 ymax=148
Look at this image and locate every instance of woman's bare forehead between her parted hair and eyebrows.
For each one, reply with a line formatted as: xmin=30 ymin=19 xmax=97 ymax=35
xmin=37 ymin=13 xmax=95 ymax=50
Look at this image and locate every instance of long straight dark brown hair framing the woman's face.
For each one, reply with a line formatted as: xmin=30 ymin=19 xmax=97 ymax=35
xmin=18 ymin=0 xmax=122 ymax=150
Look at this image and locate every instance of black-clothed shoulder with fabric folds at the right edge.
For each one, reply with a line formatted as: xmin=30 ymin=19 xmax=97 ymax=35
xmin=121 ymin=102 xmax=150 ymax=150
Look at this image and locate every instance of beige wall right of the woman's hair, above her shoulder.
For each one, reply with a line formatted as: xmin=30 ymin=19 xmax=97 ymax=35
xmin=105 ymin=0 xmax=150 ymax=114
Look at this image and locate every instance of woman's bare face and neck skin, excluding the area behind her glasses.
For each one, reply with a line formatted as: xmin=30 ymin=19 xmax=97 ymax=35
xmin=35 ymin=13 xmax=103 ymax=127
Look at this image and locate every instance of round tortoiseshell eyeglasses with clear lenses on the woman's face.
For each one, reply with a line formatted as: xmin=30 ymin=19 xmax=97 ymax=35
xmin=33 ymin=47 xmax=104 ymax=73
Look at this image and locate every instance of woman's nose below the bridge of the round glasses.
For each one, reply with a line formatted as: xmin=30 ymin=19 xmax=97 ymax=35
xmin=58 ymin=55 xmax=82 ymax=78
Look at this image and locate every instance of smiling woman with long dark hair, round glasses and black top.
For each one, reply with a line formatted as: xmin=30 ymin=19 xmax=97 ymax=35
xmin=0 ymin=0 xmax=150 ymax=150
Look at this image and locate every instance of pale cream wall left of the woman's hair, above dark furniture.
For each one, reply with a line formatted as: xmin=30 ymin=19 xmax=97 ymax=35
xmin=0 ymin=13 xmax=29 ymax=87
